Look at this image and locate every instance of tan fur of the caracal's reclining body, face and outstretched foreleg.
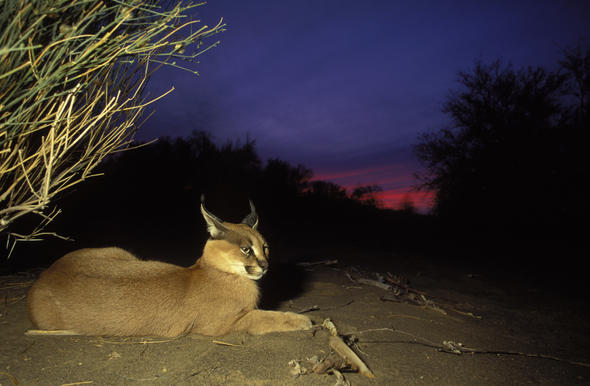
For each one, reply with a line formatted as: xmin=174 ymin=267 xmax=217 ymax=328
xmin=28 ymin=204 xmax=311 ymax=337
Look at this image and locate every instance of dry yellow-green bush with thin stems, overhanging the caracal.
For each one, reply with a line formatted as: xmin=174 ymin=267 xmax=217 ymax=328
xmin=0 ymin=0 xmax=223 ymax=250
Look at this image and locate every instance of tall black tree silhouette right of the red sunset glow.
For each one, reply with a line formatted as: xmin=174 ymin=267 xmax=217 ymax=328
xmin=415 ymin=49 xmax=590 ymax=240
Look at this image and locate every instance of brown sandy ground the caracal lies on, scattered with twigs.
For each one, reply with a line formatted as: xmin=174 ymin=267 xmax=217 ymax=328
xmin=0 ymin=250 xmax=590 ymax=385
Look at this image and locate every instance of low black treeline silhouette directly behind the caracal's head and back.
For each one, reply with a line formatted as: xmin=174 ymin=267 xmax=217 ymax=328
xmin=3 ymin=131 xmax=428 ymax=272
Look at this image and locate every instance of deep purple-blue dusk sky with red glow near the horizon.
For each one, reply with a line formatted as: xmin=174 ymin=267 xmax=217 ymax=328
xmin=138 ymin=0 xmax=590 ymax=211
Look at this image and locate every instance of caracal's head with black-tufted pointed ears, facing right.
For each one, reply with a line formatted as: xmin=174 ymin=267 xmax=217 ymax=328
xmin=201 ymin=197 xmax=269 ymax=280
